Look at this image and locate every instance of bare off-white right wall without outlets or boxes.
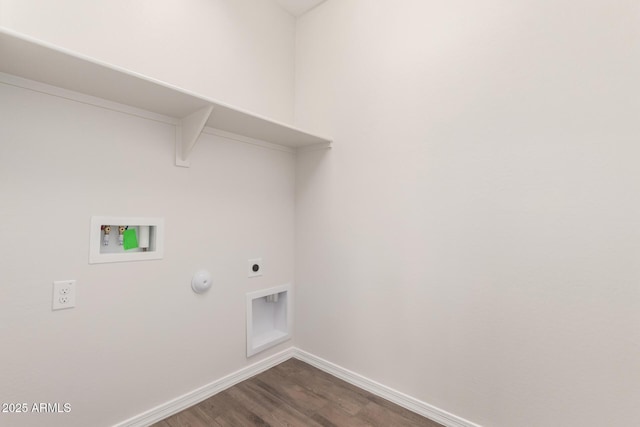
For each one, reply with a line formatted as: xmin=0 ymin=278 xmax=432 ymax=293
xmin=296 ymin=0 xmax=640 ymax=427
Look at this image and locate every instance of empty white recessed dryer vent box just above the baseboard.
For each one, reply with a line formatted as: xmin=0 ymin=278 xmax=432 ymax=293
xmin=247 ymin=285 xmax=292 ymax=357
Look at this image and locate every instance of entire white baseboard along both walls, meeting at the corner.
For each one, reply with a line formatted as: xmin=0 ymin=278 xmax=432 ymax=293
xmin=114 ymin=347 xmax=481 ymax=427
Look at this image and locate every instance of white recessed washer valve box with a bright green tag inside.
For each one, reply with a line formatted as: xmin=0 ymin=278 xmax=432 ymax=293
xmin=89 ymin=216 xmax=164 ymax=264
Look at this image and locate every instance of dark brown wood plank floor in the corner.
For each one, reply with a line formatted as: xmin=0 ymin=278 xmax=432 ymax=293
xmin=153 ymin=359 xmax=442 ymax=427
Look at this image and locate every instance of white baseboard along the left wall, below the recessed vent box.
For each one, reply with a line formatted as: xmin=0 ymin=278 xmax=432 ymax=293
xmin=114 ymin=347 xmax=294 ymax=427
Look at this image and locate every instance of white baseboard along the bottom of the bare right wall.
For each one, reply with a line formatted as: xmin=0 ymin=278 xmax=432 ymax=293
xmin=293 ymin=348 xmax=481 ymax=427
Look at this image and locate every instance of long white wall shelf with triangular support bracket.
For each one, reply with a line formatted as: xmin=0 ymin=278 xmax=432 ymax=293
xmin=0 ymin=27 xmax=331 ymax=164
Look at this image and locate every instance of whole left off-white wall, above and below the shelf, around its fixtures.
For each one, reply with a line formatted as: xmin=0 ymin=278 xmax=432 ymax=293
xmin=0 ymin=0 xmax=295 ymax=427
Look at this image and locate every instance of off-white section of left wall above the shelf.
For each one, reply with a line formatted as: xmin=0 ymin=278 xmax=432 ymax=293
xmin=0 ymin=0 xmax=295 ymax=123
